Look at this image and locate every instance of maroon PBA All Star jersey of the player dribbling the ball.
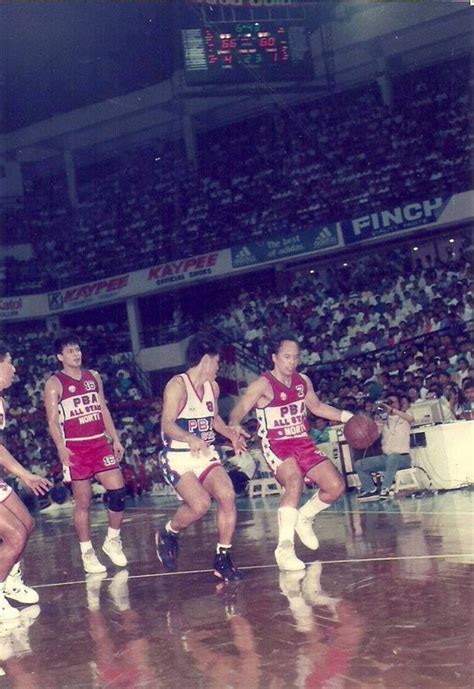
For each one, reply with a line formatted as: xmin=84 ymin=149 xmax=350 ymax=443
xmin=255 ymin=372 xmax=308 ymax=440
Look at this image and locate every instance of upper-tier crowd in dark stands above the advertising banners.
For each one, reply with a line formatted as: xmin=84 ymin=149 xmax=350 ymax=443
xmin=2 ymin=60 xmax=473 ymax=295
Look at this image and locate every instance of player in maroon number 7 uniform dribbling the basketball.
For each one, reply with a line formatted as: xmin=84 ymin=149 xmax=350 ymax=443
xmin=229 ymin=335 xmax=352 ymax=570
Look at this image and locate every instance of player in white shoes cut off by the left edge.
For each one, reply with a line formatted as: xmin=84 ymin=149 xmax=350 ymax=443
xmin=0 ymin=343 xmax=51 ymax=623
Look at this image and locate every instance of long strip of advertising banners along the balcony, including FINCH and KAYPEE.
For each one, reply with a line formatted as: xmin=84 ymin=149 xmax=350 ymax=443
xmin=0 ymin=191 xmax=474 ymax=321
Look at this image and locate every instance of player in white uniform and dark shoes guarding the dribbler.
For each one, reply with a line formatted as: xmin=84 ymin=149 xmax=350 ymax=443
xmin=156 ymin=335 xmax=248 ymax=581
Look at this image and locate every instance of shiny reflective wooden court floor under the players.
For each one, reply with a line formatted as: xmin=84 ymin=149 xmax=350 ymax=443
xmin=0 ymin=490 xmax=474 ymax=689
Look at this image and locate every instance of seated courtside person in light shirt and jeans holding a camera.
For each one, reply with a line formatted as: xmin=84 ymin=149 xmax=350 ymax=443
xmin=355 ymin=394 xmax=413 ymax=502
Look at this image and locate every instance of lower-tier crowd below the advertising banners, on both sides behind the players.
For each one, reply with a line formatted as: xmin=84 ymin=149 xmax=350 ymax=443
xmin=1 ymin=249 xmax=474 ymax=508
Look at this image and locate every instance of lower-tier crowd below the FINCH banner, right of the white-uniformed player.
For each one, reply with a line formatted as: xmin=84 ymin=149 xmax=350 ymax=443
xmin=211 ymin=249 xmax=474 ymax=420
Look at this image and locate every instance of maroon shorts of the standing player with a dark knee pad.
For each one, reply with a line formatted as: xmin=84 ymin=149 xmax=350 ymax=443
xmin=63 ymin=438 xmax=120 ymax=481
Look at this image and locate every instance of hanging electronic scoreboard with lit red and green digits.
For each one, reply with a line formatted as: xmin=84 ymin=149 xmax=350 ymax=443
xmin=182 ymin=22 xmax=313 ymax=85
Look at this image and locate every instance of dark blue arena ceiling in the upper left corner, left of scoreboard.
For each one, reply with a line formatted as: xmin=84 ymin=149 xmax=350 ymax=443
xmin=0 ymin=0 xmax=335 ymax=132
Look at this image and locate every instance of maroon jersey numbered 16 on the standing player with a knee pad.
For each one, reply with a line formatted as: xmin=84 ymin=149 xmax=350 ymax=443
xmin=55 ymin=368 xmax=105 ymax=440
